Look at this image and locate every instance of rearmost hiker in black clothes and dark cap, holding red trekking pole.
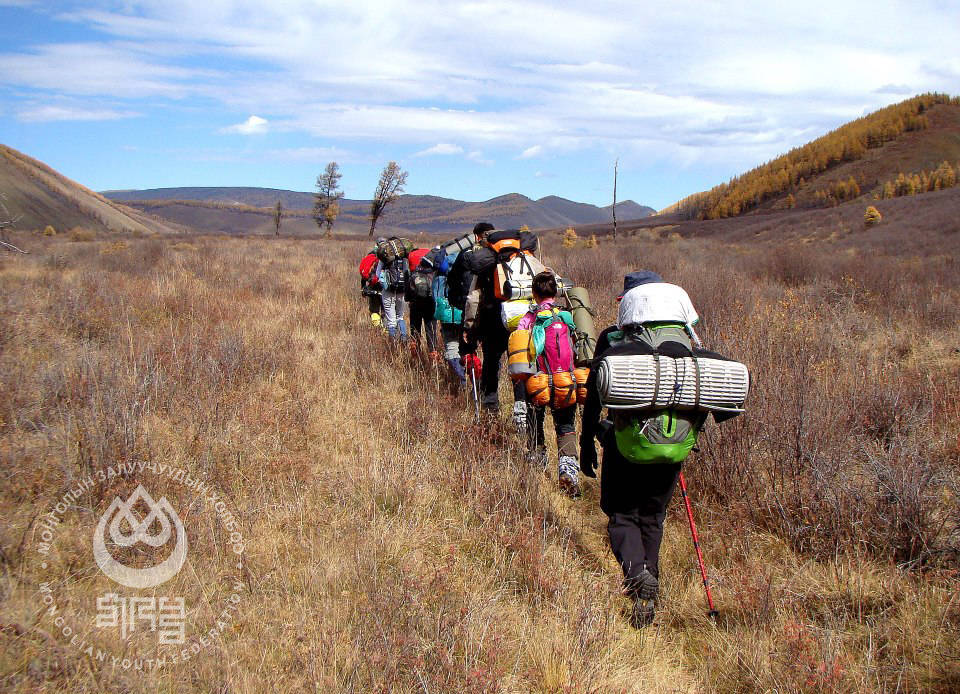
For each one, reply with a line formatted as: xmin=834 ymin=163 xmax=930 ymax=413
xmin=580 ymin=270 xmax=706 ymax=627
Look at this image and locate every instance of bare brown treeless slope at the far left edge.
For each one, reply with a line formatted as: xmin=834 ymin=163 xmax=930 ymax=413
xmin=0 ymin=145 xmax=178 ymax=234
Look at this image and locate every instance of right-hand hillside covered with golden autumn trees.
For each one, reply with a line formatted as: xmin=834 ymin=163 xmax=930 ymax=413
xmin=664 ymin=94 xmax=960 ymax=219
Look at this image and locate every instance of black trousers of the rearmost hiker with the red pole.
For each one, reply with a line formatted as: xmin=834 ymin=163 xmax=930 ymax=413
xmin=600 ymin=431 xmax=680 ymax=587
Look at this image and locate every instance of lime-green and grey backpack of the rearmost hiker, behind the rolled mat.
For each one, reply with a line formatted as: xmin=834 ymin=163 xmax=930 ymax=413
xmin=609 ymin=324 xmax=708 ymax=464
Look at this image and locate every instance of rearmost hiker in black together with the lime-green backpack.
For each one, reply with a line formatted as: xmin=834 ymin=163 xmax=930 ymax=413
xmin=580 ymin=270 xmax=712 ymax=627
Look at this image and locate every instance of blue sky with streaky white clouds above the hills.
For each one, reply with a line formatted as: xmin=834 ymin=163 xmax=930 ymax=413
xmin=0 ymin=0 xmax=960 ymax=209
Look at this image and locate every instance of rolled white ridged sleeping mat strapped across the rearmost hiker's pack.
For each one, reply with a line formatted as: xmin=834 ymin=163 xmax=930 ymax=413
xmin=597 ymin=354 xmax=750 ymax=412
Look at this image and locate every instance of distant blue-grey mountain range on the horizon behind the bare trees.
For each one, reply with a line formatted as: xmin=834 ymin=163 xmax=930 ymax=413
xmin=103 ymin=188 xmax=654 ymax=234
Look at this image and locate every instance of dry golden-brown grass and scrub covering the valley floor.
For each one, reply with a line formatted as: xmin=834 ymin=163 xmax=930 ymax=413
xmin=0 ymin=231 xmax=960 ymax=692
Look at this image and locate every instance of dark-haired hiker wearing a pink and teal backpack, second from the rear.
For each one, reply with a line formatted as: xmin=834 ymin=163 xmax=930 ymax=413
xmin=514 ymin=270 xmax=580 ymax=498
